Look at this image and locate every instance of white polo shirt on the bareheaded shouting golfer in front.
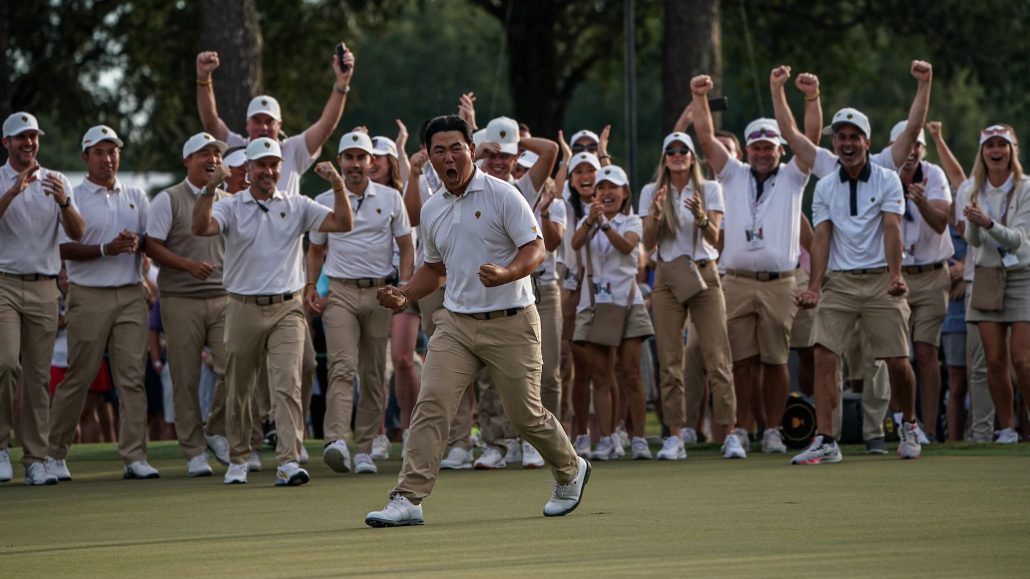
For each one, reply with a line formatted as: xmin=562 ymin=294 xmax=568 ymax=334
xmin=421 ymin=168 xmax=541 ymax=313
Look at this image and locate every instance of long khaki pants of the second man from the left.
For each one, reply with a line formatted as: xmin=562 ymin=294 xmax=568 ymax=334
xmin=49 ymin=283 xmax=149 ymax=465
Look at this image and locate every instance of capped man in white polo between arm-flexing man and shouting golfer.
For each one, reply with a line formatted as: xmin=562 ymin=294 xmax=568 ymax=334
xmin=305 ymin=131 xmax=414 ymax=474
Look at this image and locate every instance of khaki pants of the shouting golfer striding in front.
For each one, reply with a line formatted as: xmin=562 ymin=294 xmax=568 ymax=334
xmin=391 ymin=306 xmax=579 ymax=503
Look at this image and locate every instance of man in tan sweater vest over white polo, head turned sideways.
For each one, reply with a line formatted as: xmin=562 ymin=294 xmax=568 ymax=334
xmin=146 ymin=133 xmax=229 ymax=476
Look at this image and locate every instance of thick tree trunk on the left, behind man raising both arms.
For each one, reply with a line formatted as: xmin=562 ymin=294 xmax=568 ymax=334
xmin=198 ymin=0 xmax=263 ymax=133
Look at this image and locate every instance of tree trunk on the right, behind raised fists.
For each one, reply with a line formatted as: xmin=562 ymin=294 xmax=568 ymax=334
xmin=661 ymin=0 xmax=722 ymax=132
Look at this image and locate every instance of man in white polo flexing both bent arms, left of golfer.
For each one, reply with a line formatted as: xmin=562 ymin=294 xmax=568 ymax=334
xmin=193 ymin=138 xmax=352 ymax=486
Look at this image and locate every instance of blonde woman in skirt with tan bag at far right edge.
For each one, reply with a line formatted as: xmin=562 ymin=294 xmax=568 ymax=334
xmin=959 ymin=125 xmax=1030 ymax=444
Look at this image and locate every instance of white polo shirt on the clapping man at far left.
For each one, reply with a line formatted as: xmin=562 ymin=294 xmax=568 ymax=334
xmin=0 ymin=161 xmax=77 ymax=275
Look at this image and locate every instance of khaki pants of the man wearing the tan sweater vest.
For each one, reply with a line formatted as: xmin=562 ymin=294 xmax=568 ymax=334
xmin=161 ymin=296 xmax=229 ymax=458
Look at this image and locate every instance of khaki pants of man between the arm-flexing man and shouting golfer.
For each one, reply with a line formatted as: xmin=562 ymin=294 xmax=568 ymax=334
xmin=322 ymin=279 xmax=392 ymax=454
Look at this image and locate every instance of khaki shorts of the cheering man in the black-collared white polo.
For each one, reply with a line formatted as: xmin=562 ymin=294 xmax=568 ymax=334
xmin=815 ymin=272 xmax=909 ymax=360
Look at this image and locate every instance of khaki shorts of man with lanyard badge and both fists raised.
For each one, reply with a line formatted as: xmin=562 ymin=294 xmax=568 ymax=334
xmin=722 ymin=274 xmax=797 ymax=365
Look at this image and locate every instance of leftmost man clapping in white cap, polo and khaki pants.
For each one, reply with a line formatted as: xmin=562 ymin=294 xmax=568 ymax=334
xmin=0 ymin=112 xmax=84 ymax=485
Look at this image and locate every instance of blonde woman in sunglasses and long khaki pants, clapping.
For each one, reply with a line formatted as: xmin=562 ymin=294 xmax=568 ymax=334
xmin=640 ymin=133 xmax=747 ymax=461
